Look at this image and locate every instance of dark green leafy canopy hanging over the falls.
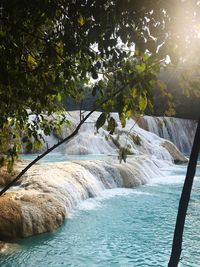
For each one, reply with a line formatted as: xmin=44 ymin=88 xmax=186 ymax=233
xmin=0 ymin=0 xmax=199 ymax=169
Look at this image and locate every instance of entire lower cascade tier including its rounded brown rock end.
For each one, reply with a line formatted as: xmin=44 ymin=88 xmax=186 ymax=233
xmin=0 ymin=156 xmax=167 ymax=239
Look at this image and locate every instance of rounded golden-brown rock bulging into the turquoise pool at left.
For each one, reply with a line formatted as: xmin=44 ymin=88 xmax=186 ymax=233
xmin=0 ymin=190 xmax=65 ymax=240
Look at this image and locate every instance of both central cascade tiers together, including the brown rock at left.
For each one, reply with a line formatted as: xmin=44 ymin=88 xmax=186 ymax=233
xmin=0 ymin=112 xmax=189 ymax=239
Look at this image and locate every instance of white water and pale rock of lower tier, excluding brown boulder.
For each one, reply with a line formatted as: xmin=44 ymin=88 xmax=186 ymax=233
xmin=21 ymin=156 xmax=160 ymax=214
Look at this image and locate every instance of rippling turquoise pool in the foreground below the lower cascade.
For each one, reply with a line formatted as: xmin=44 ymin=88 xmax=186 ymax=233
xmin=0 ymin=166 xmax=200 ymax=267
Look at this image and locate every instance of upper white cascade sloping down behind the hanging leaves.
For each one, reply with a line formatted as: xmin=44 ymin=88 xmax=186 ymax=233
xmin=43 ymin=111 xmax=184 ymax=161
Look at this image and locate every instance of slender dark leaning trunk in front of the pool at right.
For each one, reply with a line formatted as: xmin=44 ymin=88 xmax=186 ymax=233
xmin=168 ymin=119 xmax=200 ymax=267
